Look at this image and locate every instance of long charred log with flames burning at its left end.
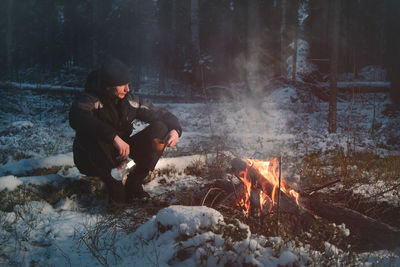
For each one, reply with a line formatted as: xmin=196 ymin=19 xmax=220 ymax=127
xmin=231 ymin=158 xmax=400 ymax=251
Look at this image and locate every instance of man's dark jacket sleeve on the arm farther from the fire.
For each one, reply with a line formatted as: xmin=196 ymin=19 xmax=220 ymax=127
xmin=69 ymin=94 xmax=117 ymax=142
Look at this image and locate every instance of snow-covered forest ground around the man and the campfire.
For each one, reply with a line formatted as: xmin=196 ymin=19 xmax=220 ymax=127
xmin=0 ymin=83 xmax=400 ymax=266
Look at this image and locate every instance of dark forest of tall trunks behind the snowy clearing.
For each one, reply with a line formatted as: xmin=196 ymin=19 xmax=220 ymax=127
xmin=0 ymin=0 xmax=400 ymax=96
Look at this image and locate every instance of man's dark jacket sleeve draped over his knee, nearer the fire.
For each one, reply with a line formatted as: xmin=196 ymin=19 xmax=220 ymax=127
xmin=131 ymin=97 xmax=182 ymax=137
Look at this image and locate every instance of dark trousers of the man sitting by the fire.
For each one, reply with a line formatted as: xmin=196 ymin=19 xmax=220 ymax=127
xmin=74 ymin=121 xmax=168 ymax=194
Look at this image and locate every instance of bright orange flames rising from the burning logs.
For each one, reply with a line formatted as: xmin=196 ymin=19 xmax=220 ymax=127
xmin=239 ymin=158 xmax=300 ymax=216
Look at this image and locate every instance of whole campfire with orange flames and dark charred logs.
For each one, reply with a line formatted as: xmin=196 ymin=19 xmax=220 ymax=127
xmin=201 ymin=158 xmax=400 ymax=251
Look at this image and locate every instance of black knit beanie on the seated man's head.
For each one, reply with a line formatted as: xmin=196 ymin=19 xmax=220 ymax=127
xmin=100 ymin=56 xmax=131 ymax=87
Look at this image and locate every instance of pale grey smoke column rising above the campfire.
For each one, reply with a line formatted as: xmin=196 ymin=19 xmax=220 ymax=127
xmin=220 ymin=37 xmax=286 ymax=157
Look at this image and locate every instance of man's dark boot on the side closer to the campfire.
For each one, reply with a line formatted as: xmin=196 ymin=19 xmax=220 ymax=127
xmin=125 ymin=166 xmax=150 ymax=203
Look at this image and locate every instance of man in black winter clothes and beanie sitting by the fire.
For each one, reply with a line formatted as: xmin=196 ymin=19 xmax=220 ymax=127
xmin=69 ymin=57 xmax=182 ymax=203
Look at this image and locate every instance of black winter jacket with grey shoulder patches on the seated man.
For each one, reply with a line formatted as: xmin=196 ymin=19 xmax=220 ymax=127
xmin=69 ymin=71 xmax=182 ymax=172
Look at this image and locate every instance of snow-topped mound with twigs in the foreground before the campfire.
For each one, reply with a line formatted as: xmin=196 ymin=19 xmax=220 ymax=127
xmin=119 ymin=206 xmax=308 ymax=266
